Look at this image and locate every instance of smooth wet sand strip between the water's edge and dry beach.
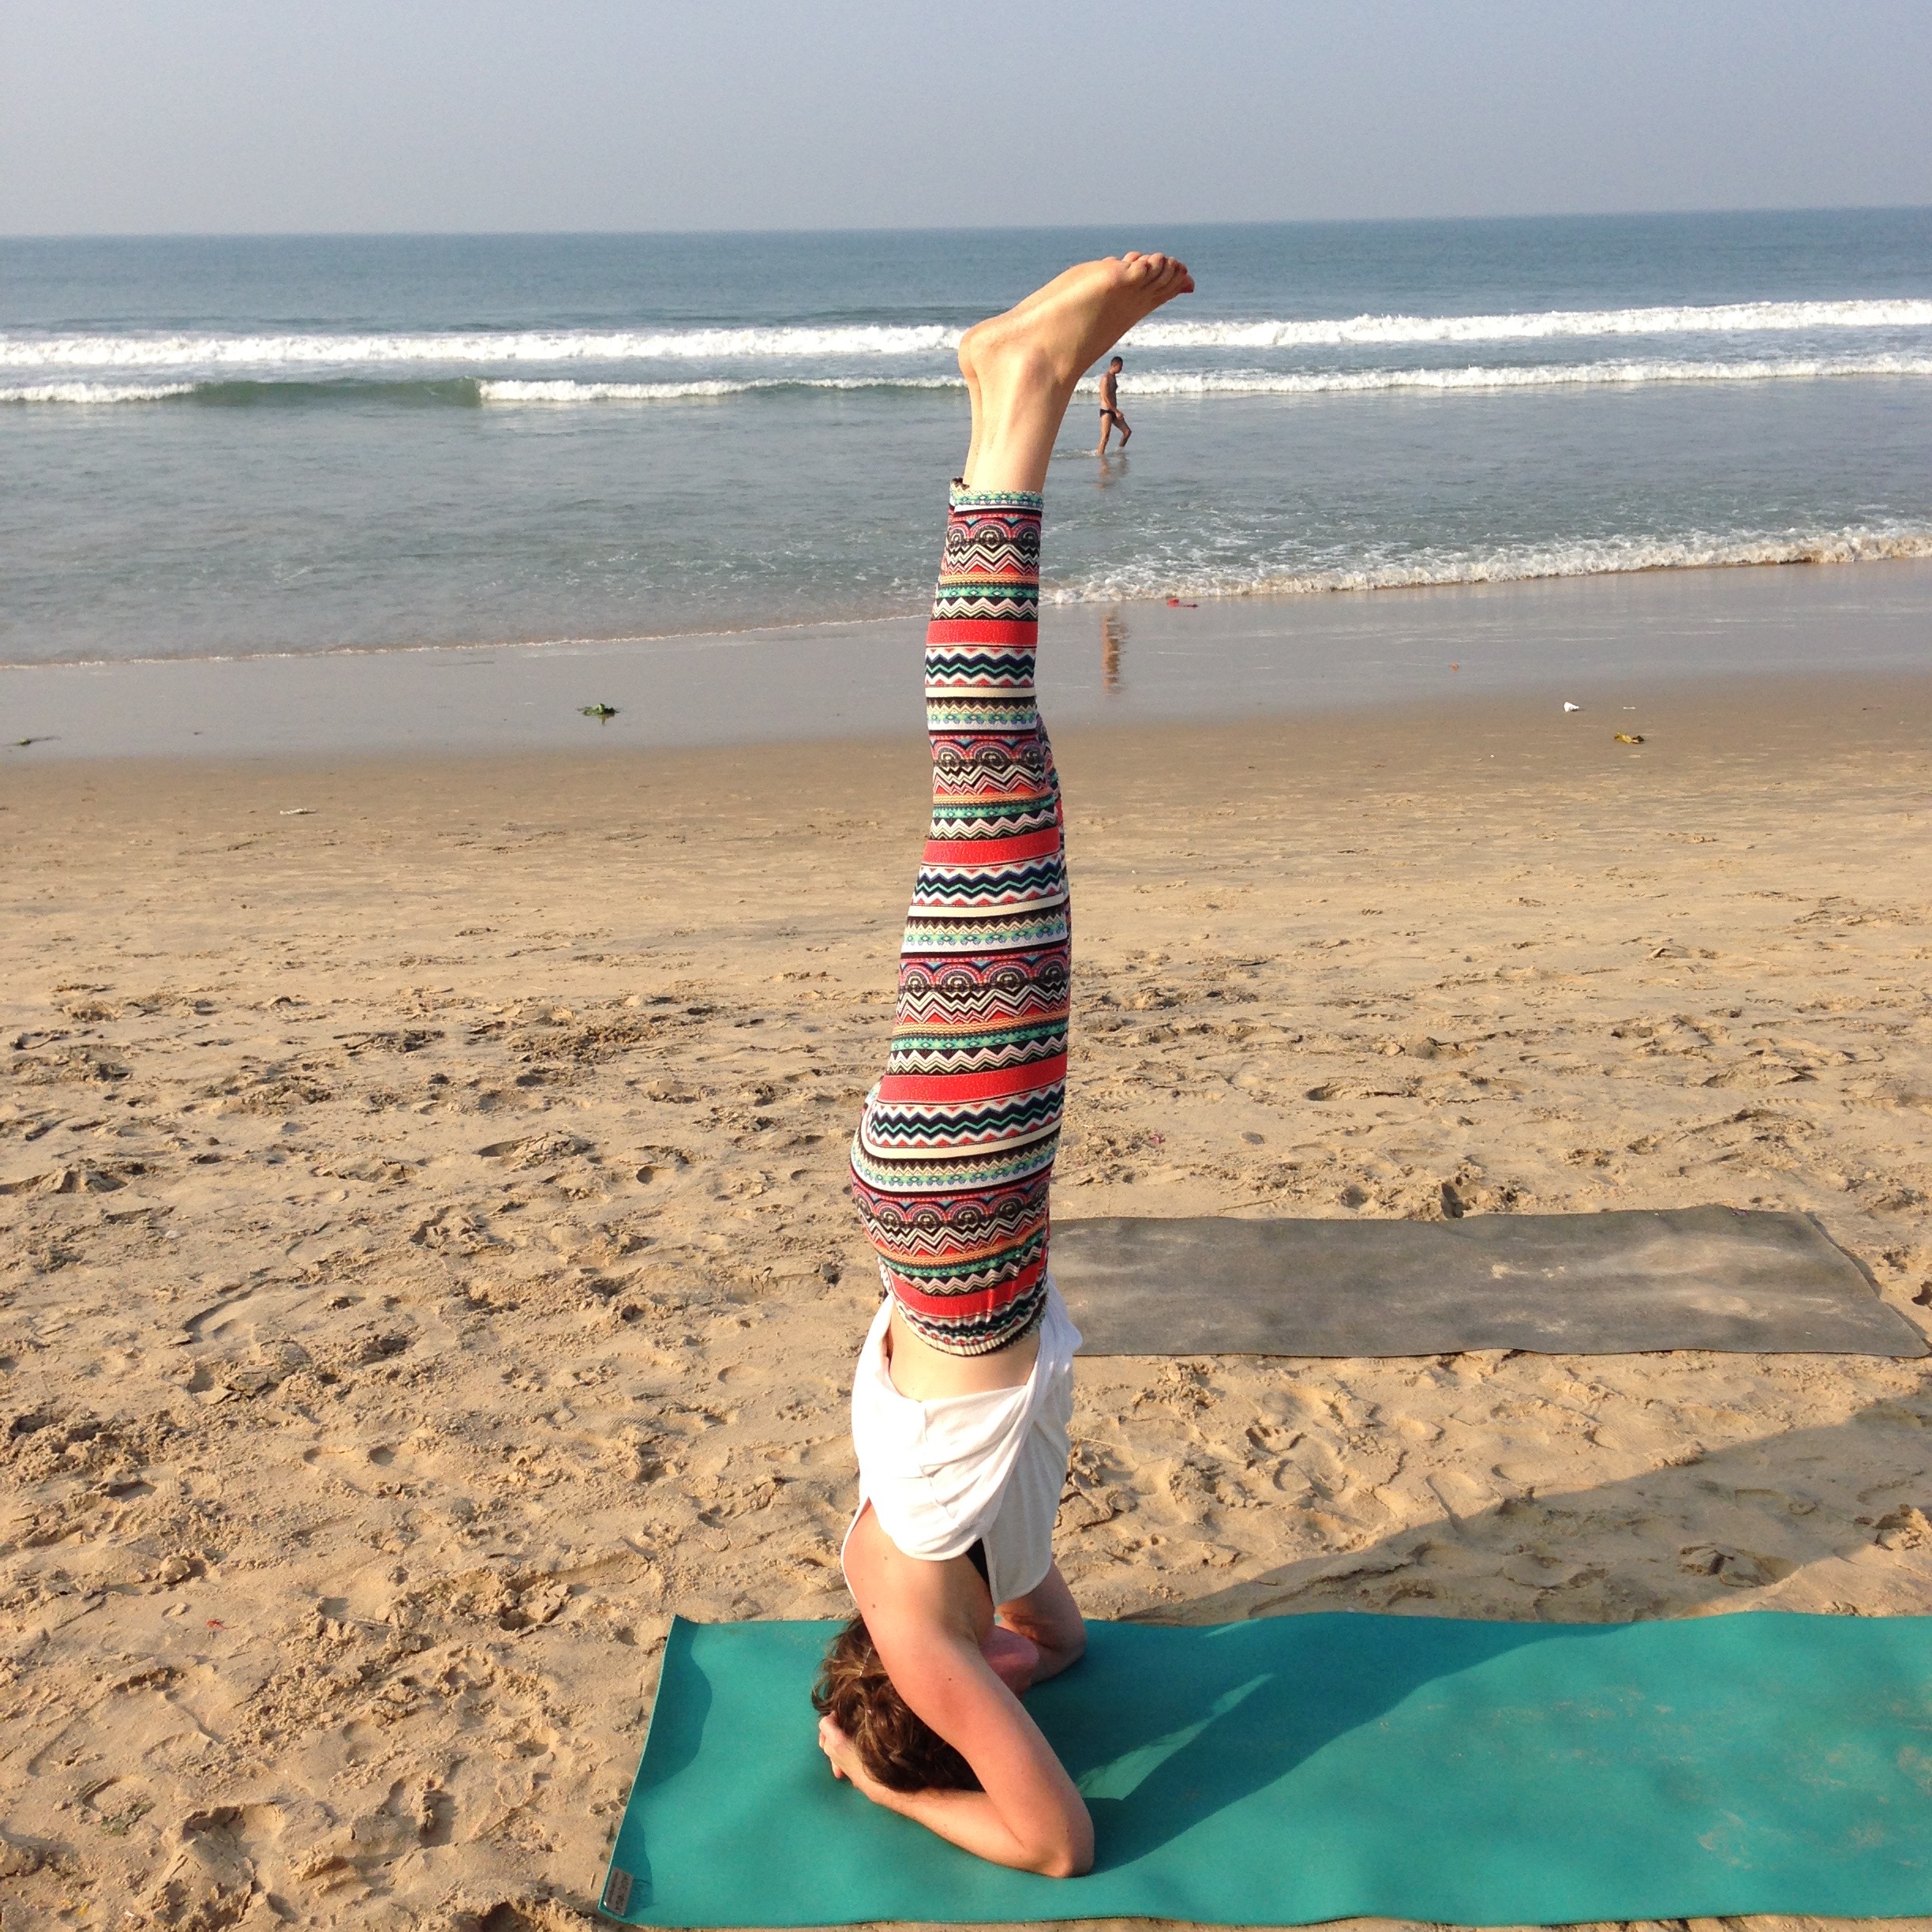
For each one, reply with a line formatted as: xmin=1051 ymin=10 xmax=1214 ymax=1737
xmin=0 ymin=560 xmax=1932 ymax=769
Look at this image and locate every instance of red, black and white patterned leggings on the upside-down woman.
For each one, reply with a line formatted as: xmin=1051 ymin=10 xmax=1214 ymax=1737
xmin=852 ymin=489 xmax=1073 ymax=1354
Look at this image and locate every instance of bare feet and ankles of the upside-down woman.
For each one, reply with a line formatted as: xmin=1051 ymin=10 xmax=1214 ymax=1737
xmin=960 ymin=253 xmax=1194 ymax=491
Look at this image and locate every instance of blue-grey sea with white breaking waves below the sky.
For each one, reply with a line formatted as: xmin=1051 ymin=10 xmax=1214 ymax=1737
xmin=0 ymin=211 xmax=1932 ymax=665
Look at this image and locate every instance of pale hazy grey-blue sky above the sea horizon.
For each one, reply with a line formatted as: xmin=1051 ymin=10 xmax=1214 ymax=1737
xmin=0 ymin=0 xmax=1932 ymax=234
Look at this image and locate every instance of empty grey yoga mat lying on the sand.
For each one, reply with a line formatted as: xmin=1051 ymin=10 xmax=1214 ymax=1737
xmin=1053 ymin=1208 xmax=1932 ymax=1356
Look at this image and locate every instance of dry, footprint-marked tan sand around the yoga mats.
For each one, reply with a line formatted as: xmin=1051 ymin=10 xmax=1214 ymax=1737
xmin=0 ymin=678 xmax=1932 ymax=1932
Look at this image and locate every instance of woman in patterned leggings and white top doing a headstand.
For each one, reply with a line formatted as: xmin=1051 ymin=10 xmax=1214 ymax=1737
xmin=815 ymin=255 xmax=1194 ymax=1876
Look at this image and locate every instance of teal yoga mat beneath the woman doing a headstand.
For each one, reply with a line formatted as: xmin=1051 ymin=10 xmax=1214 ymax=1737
xmin=603 ymin=1612 xmax=1932 ymax=1926
